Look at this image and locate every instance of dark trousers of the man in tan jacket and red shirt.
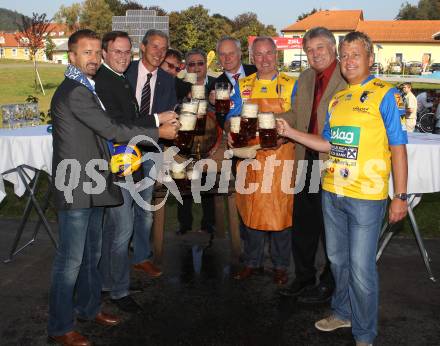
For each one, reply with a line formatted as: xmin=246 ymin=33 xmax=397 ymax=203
xmin=291 ymin=151 xmax=334 ymax=287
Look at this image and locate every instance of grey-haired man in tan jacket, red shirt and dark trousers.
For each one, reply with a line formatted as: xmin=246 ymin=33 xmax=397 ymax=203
xmin=280 ymin=27 xmax=347 ymax=304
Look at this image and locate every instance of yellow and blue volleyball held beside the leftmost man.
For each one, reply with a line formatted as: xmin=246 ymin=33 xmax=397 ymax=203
xmin=110 ymin=144 xmax=142 ymax=177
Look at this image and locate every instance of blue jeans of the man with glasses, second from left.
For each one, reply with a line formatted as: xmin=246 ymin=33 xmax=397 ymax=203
xmin=99 ymin=189 xmax=134 ymax=299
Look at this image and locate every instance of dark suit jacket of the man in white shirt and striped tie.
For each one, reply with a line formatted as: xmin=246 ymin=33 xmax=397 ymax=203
xmin=125 ymin=60 xmax=177 ymax=113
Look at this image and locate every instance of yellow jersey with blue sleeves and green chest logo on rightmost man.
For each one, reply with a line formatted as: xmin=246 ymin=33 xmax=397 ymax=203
xmin=322 ymin=76 xmax=408 ymax=200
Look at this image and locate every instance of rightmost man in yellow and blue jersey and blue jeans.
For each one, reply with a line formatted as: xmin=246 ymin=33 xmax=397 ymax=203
xmin=278 ymin=31 xmax=407 ymax=346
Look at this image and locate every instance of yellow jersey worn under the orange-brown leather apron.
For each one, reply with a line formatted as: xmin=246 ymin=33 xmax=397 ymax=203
xmin=226 ymin=73 xmax=297 ymax=120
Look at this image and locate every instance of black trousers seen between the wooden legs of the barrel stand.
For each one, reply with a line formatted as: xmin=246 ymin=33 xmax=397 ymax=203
xmin=177 ymin=194 xmax=215 ymax=233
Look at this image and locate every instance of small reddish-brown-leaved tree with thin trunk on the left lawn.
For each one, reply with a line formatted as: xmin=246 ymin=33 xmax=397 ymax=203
xmin=15 ymin=12 xmax=51 ymax=95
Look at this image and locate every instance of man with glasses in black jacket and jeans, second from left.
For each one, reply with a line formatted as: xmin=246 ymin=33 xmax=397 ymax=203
xmin=94 ymin=31 xmax=176 ymax=312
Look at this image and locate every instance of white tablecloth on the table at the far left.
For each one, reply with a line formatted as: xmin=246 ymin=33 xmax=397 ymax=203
xmin=0 ymin=125 xmax=52 ymax=202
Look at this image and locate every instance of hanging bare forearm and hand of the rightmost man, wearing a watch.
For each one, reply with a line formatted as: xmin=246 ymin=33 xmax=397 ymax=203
xmin=388 ymin=144 xmax=408 ymax=223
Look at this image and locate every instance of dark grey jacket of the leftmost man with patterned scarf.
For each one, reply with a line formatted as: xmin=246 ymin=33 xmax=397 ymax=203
xmin=50 ymin=78 xmax=158 ymax=209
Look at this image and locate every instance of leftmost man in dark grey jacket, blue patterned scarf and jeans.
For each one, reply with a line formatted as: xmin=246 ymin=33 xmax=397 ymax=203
xmin=48 ymin=30 xmax=177 ymax=346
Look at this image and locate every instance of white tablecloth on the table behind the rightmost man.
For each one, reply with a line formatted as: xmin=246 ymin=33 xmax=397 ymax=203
xmin=389 ymin=133 xmax=440 ymax=197
